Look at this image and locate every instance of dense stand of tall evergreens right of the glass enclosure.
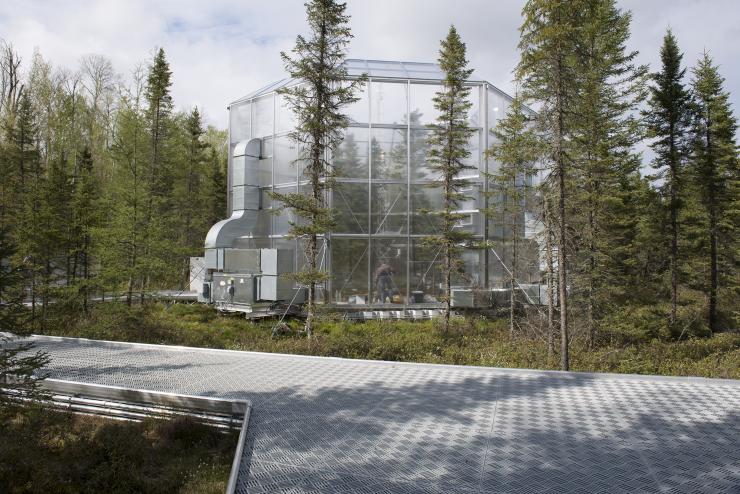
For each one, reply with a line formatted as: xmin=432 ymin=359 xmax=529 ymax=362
xmin=490 ymin=0 xmax=740 ymax=369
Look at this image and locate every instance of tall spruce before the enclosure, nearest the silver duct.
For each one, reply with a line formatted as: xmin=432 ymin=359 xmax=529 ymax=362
xmin=273 ymin=0 xmax=364 ymax=338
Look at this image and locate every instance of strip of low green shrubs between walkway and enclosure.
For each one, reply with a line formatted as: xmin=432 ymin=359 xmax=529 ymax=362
xmin=30 ymin=303 xmax=740 ymax=379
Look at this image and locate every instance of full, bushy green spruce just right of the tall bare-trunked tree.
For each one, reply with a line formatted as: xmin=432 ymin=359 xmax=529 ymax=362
xmin=569 ymin=0 xmax=647 ymax=347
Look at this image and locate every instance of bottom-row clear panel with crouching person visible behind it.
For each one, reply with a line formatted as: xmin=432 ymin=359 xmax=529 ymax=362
xmin=370 ymin=237 xmax=408 ymax=304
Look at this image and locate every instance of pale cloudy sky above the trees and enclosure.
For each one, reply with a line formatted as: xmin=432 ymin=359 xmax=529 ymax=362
xmin=0 ymin=0 xmax=740 ymax=127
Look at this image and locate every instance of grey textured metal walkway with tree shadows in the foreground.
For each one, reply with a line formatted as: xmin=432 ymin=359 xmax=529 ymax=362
xmin=26 ymin=337 xmax=740 ymax=494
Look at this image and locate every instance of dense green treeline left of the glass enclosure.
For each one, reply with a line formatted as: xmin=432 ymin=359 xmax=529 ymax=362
xmin=0 ymin=42 xmax=227 ymax=320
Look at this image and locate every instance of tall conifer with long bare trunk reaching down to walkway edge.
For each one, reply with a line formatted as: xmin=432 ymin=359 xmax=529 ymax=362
xmin=516 ymin=0 xmax=583 ymax=370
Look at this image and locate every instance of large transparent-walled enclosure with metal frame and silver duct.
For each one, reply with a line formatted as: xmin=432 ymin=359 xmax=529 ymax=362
xmin=199 ymin=60 xmax=540 ymax=307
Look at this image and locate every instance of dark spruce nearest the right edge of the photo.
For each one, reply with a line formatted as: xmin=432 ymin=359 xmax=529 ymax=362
xmin=690 ymin=52 xmax=738 ymax=331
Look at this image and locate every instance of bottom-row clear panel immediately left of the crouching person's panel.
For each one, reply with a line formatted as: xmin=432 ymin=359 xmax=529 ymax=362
xmin=331 ymin=237 xmax=370 ymax=305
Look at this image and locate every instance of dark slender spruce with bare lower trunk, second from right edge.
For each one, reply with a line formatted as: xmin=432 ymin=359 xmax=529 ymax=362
xmin=644 ymin=30 xmax=691 ymax=328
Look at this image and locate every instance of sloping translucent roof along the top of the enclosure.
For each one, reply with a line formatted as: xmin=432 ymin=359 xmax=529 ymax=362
xmin=231 ymin=59 xmax=488 ymax=105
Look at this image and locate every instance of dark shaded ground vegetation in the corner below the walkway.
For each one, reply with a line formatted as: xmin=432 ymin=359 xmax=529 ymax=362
xmin=0 ymin=409 xmax=237 ymax=494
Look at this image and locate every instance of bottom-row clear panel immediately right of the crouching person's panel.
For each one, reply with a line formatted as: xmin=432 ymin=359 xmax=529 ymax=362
xmin=409 ymin=239 xmax=443 ymax=304
